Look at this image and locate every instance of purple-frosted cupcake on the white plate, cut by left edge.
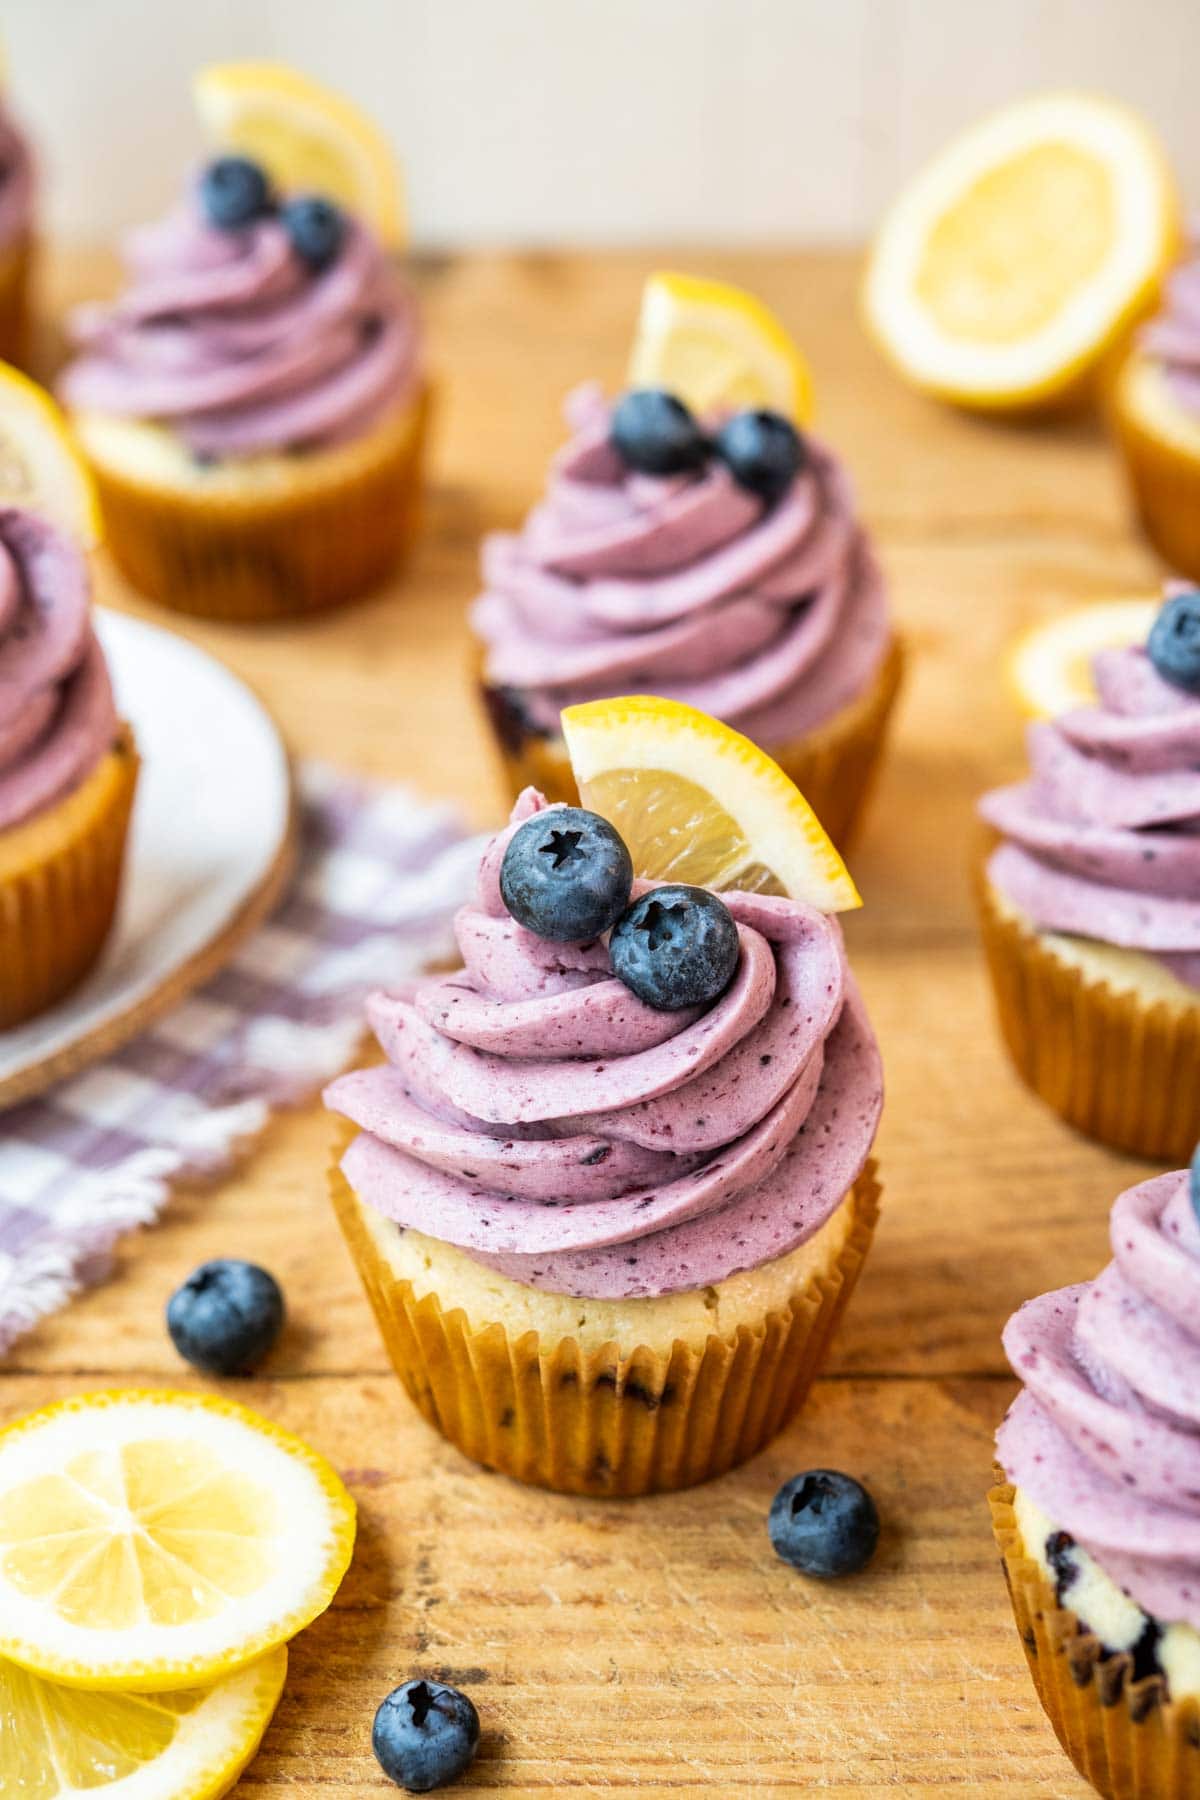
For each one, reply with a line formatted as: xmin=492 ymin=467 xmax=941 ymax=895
xmin=0 ymin=508 xmax=137 ymax=1030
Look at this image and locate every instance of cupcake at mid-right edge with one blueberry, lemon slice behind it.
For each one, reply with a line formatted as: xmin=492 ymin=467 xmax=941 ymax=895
xmin=979 ymin=590 xmax=1200 ymax=1163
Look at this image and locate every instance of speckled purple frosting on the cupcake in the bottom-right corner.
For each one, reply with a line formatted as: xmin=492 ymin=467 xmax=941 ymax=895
xmin=997 ymin=1170 xmax=1200 ymax=1629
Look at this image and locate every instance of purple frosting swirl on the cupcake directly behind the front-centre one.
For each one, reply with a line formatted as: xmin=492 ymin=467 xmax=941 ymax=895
xmin=473 ymin=387 xmax=891 ymax=745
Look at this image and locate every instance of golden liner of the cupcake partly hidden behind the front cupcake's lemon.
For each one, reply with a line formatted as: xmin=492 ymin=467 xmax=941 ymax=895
xmin=479 ymin=637 xmax=905 ymax=850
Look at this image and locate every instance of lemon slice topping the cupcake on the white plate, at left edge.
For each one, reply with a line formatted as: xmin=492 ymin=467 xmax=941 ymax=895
xmin=0 ymin=362 xmax=101 ymax=545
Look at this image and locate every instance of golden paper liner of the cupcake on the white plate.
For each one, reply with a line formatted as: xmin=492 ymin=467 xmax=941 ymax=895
xmin=0 ymin=731 xmax=139 ymax=1030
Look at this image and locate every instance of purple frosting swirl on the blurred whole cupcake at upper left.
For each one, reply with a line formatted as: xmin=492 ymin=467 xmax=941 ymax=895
xmin=61 ymin=187 xmax=421 ymax=457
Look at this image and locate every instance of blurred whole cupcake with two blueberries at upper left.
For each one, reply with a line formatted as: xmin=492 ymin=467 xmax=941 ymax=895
xmin=61 ymin=79 xmax=428 ymax=619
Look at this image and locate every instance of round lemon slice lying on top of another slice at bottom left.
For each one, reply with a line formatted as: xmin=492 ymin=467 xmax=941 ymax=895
xmin=0 ymin=1391 xmax=354 ymax=1692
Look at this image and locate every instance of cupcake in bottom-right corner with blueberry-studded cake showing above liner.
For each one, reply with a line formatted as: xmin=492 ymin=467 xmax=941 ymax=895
xmin=990 ymin=1170 xmax=1200 ymax=1800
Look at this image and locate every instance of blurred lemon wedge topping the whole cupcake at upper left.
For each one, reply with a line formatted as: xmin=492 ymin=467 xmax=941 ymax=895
xmin=193 ymin=63 xmax=405 ymax=248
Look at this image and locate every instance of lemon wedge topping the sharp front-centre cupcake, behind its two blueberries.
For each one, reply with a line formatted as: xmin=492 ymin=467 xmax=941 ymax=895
xmin=563 ymin=698 xmax=862 ymax=913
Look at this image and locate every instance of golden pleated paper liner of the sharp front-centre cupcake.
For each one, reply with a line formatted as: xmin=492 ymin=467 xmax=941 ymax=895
xmin=329 ymin=1130 xmax=880 ymax=1498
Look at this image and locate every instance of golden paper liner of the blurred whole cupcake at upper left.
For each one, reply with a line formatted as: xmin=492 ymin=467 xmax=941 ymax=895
xmin=92 ymin=389 xmax=430 ymax=623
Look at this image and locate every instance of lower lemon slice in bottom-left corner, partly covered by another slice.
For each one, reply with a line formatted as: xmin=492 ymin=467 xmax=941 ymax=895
xmin=0 ymin=1649 xmax=288 ymax=1800
